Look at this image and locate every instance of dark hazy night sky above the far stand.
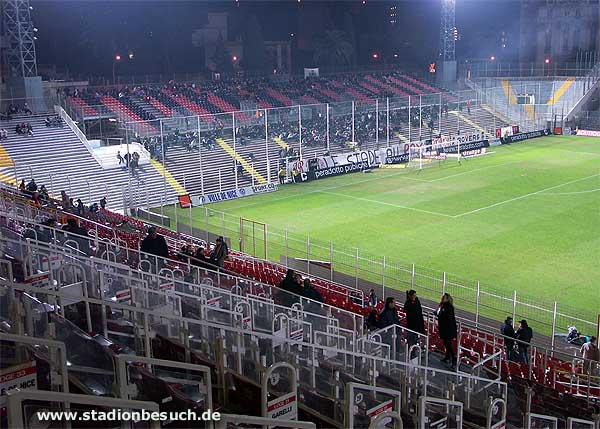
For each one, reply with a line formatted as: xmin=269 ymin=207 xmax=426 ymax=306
xmin=30 ymin=0 xmax=519 ymax=76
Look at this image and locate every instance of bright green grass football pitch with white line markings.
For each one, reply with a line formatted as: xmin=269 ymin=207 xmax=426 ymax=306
xmin=165 ymin=136 xmax=600 ymax=321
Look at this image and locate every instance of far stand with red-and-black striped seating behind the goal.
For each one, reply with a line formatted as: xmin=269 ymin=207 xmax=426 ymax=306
xmin=54 ymin=73 xmax=508 ymax=194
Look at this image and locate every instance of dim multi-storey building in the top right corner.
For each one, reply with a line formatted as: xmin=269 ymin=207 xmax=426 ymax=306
xmin=519 ymin=0 xmax=600 ymax=64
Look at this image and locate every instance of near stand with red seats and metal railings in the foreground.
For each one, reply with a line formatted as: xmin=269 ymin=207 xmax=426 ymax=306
xmin=0 ymin=185 xmax=600 ymax=427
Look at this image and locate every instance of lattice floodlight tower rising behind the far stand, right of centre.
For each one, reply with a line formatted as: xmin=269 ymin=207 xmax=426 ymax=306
xmin=438 ymin=0 xmax=457 ymax=84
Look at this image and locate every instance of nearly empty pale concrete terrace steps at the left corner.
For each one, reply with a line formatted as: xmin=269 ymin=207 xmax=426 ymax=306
xmin=0 ymin=112 xmax=177 ymax=210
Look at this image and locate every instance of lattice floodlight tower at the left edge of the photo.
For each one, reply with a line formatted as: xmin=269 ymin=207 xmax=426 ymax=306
xmin=0 ymin=0 xmax=43 ymax=108
